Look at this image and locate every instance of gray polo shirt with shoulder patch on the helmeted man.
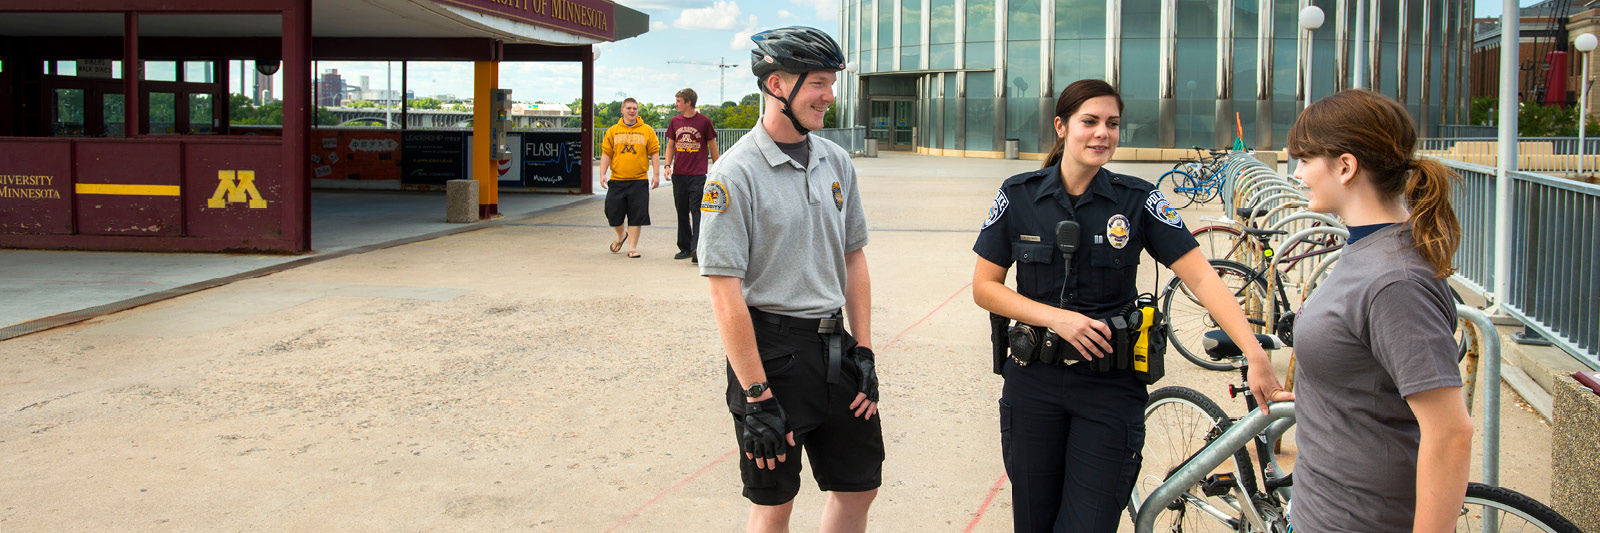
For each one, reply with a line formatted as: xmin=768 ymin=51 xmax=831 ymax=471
xmin=694 ymin=123 xmax=867 ymax=319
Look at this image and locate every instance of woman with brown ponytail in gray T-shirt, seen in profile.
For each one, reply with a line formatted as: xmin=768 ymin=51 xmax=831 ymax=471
xmin=1250 ymin=90 xmax=1472 ymax=531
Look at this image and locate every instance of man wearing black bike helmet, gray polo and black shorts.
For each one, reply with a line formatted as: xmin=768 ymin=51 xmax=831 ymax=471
xmin=696 ymin=27 xmax=883 ymax=531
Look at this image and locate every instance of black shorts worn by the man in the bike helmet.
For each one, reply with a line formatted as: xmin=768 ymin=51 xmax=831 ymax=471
xmin=728 ymin=313 xmax=883 ymax=506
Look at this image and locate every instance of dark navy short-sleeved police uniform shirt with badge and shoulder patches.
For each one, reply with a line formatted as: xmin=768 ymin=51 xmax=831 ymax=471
xmin=973 ymin=165 xmax=1200 ymax=319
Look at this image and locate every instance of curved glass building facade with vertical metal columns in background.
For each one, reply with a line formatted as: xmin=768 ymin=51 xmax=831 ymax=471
xmin=838 ymin=0 xmax=1472 ymax=157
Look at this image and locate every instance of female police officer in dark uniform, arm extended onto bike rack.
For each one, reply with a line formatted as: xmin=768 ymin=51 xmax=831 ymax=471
xmin=973 ymin=80 xmax=1280 ymax=531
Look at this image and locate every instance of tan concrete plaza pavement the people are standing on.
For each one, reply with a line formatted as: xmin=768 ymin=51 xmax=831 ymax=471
xmin=0 ymin=154 xmax=1550 ymax=531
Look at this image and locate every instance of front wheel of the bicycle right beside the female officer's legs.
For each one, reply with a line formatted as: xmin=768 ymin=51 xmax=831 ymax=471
xmin=1128 ymin=387 xmax=1254 ymax=531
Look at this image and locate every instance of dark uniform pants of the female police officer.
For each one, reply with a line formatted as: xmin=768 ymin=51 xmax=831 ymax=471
xmin=1000 ymin=355 xmax=1150 ymax=533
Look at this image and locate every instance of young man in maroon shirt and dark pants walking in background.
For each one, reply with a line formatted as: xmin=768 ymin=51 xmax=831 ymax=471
xmin=666 ymin=88 xmax=717 ymax=262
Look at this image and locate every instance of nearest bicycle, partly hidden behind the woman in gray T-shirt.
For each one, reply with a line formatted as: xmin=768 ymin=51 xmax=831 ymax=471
xmin=1128 ymin=331 xmax=1579 ymax=533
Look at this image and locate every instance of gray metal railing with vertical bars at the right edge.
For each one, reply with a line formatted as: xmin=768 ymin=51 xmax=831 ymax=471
xmin=1440 ymin=158 xmax=1600 ymax=368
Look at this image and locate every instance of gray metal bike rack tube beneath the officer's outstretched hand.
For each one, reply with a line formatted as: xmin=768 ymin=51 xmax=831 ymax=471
xmin=1133 ymin=402 xmax=1294 ymax=533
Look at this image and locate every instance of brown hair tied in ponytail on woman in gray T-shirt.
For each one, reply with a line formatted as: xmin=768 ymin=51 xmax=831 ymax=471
xmin=1288 ymin=90 xmax=1461 ymax=277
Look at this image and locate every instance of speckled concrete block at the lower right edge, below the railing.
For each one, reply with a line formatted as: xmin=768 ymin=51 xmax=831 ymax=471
xmin=1550 ymin=371 xmax=1600 ymax=531
